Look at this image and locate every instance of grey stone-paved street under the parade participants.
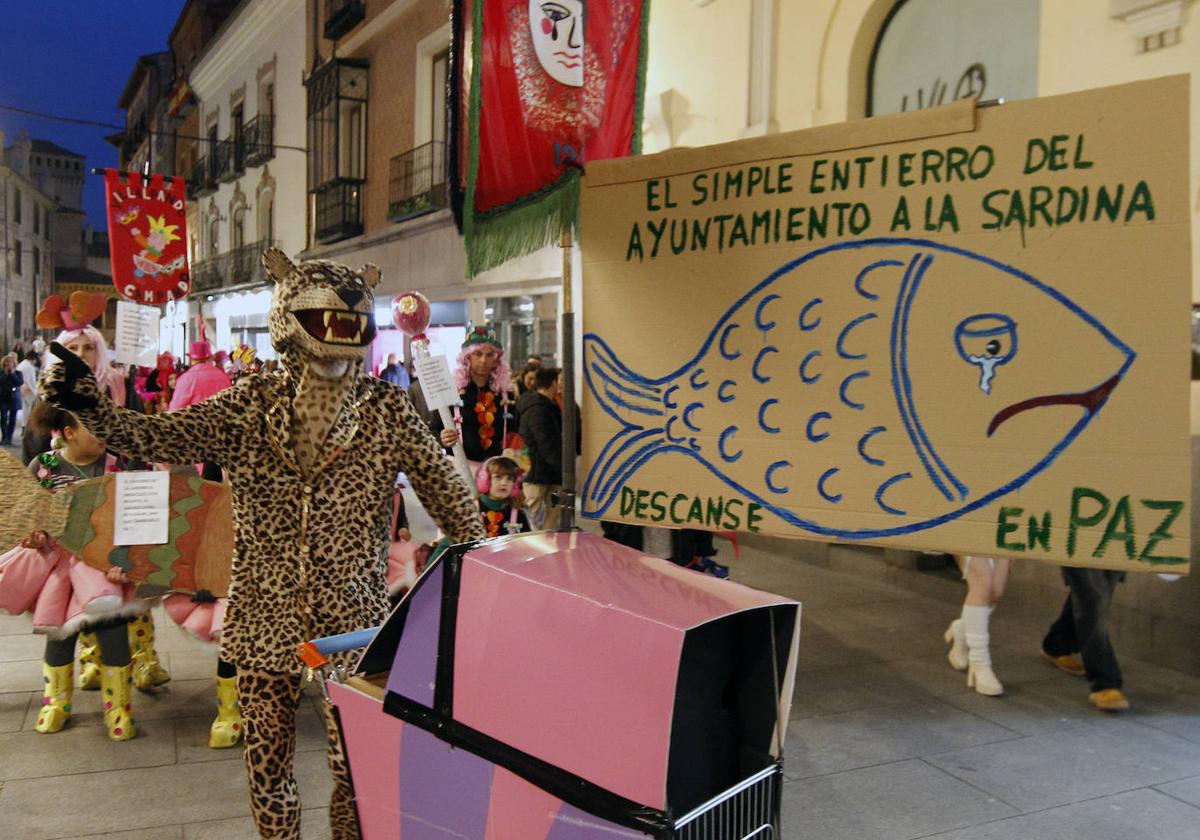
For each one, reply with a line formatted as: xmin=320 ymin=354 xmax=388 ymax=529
xmin=0 ymin=530 xmax=1200 ymax=840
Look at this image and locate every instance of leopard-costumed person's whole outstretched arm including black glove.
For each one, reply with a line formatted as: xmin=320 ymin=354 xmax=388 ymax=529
xmin=38 ymin=342 xmax=238 ymax=463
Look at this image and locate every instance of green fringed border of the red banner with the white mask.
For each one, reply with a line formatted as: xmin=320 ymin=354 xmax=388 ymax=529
xmin=463 ymin=0 xmax=650 ymax=278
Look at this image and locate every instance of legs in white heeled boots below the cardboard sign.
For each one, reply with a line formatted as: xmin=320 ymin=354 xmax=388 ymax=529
xmin=944 ymin=556 xmax=1009 ymax=697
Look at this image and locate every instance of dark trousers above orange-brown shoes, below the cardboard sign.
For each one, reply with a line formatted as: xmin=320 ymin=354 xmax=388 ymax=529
xmin=1042 ymin=566 xmax=1124 ymax=691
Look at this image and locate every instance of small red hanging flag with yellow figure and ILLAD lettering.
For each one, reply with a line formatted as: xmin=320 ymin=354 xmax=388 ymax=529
xmin=104 ymin=169 xmax=192 ymax=304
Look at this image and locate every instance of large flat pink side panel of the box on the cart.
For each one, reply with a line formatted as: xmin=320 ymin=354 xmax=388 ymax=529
xmin=454 ymin=553 xmax=698 ymax=808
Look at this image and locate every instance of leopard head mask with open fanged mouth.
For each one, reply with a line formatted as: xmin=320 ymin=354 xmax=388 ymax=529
xmin=263 ymin=248 xmax=380 ymax=367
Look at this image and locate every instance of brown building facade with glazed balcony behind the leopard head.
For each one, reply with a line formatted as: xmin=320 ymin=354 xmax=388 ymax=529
xmin=304 ymin=0 xmax=562 ymax=374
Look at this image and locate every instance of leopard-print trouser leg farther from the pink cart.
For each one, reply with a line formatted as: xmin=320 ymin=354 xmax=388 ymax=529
xmin=238 ymin=671 xmax=300 ymax=840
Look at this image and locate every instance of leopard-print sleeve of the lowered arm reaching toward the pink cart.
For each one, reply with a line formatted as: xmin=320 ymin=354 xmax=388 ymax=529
xmin=392 ymin=389 xmax=486 ymax=542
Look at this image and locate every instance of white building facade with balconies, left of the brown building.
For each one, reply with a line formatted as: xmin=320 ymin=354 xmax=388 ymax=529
xmin=186 ymin=0 xmax=306 ymax=358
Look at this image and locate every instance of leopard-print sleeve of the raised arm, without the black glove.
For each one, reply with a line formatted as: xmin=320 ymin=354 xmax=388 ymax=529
xmin=76 ymin=382 xmax=253 ymax=463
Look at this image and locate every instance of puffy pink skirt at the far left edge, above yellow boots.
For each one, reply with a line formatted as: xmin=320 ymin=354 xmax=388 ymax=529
xmin=0 ymin=545 xmax=155 ymax=638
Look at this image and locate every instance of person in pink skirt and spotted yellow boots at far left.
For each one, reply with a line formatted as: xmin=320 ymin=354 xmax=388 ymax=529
xmin=0 ymin=403 xmax=151 ymax=740
